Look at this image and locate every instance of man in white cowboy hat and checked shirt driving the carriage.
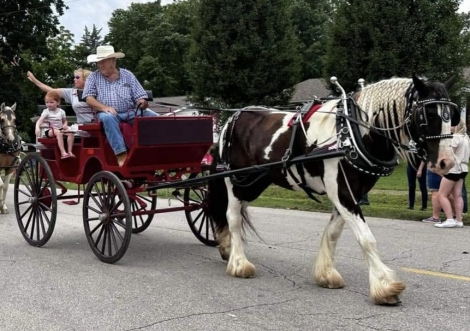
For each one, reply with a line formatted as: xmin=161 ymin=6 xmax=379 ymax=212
xmin=82 ymin=45 xmax=157 ymax=167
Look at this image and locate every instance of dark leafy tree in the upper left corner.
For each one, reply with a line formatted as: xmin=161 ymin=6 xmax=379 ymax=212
xmin=0 ymin=0 xmax=66 ymax=139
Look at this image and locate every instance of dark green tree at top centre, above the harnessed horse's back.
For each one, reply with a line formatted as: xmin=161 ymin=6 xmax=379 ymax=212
xmin=188 ymin=0 xmax=300 ymax=107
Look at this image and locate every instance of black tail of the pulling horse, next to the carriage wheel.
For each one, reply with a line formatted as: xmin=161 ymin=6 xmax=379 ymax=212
xmin=207 ymin=144 xmax=228 ymax=239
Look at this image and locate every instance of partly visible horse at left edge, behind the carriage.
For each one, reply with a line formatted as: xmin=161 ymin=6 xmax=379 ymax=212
xmin=0 ymin=103 xmax=21 ymax=214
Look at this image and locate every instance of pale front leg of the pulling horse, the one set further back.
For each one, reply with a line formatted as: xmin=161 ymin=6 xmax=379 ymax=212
xmin=312 ymin=209 xmax=344 ymax=288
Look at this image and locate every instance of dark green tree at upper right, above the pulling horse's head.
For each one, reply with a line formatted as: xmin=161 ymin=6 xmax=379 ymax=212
xmin=324 ymin=0 xmax=468 ymax=90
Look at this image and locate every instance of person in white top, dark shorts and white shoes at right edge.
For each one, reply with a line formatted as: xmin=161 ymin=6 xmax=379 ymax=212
xmin=435 ymin=120 xmax=470 ymax=228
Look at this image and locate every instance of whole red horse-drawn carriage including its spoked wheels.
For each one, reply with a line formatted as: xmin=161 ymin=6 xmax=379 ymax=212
xmin=14 ymin=110 xmax=216 ymax=263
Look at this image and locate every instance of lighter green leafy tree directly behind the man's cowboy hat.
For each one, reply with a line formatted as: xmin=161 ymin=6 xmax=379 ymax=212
xmin=105 ymin=0 xmax=197 ymax=96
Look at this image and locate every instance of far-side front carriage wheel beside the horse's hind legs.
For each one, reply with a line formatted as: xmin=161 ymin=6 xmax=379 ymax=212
xmin=184 ymin=173 xmax=219 ymax=246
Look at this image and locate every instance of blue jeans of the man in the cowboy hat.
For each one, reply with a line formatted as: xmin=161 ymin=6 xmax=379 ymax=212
xmin=96 ymin=109 xmax=158 ymax=155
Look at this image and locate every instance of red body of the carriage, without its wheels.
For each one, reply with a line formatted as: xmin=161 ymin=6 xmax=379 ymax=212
xmin=38 ymin=116 xmax=213 ymax=184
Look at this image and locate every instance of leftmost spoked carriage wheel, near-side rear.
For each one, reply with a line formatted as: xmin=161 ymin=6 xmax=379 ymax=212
xmin=14 ymin=153 xmax=57 ymax=247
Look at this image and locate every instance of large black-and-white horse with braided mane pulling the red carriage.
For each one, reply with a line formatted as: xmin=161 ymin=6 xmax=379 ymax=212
xmin=209 ymin=76 xmax=460 ymax=305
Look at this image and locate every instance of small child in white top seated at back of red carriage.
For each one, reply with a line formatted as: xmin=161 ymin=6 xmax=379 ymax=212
xmin=36 ymin=91 xmax=75 ymax=159
